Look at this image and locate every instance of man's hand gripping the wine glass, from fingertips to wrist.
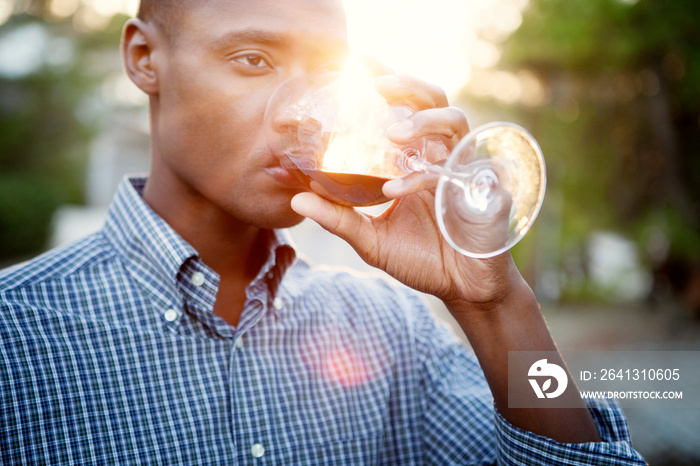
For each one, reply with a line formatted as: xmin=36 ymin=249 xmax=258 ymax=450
xmin=292 ymin=75 xmax=522 ymax=310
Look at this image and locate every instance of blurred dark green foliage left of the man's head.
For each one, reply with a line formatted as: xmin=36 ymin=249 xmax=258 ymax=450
xmin=0 ymin=9 xmax=123 ymax=263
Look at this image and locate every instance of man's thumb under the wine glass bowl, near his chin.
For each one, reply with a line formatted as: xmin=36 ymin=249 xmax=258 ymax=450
xmin=291 ymin=192 xmax=373 ymax=255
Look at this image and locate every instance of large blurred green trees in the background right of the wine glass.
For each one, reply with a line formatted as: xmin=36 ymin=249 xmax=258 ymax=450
xmin=499 ymin=0 xmax=700 ymax=304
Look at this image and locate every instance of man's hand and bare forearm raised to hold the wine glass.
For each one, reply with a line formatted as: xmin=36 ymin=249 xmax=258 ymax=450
xmin=292 ymin=76 xmax=600 ymax=443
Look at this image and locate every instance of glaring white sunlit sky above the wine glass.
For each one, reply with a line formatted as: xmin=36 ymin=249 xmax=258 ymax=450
xmin=344 ymin=0 xmax=528 ymax=94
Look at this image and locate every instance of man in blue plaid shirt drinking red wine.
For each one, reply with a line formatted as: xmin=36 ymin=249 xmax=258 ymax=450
xmin=0 ymin=0 xmax=643 ymax=465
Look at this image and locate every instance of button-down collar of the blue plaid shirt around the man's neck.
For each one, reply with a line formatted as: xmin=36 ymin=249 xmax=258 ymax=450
xmin=103 ymin=177 xmax=296 ymax=326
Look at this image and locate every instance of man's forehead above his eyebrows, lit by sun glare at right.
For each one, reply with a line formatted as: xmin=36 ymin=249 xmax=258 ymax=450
xmin=177 ymin=0 xmax=347 ymax=46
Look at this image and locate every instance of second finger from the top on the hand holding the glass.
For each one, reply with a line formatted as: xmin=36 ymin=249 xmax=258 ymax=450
xmin=387 ymin=107 xmax=469 ymax=144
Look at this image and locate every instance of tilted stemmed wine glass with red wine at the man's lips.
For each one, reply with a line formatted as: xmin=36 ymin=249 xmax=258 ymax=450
xmin=264 ymin=71 xmax=546 ymax=258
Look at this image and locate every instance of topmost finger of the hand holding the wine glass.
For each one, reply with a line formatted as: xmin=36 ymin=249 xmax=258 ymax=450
xmin=375 ymin=74 xmax=449 ymax=110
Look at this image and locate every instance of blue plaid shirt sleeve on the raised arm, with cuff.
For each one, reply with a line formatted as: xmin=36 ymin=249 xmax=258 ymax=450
xmin=414 ymin=290 xmax=646 ymax=466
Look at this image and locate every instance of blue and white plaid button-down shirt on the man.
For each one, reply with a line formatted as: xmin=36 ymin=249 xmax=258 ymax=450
xmin=0 ymin=179 xmax=644 ymax=465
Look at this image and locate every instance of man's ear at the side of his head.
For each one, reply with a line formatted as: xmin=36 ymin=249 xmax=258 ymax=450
xmin=121 ymin=18 xmax=158 ymax=95
